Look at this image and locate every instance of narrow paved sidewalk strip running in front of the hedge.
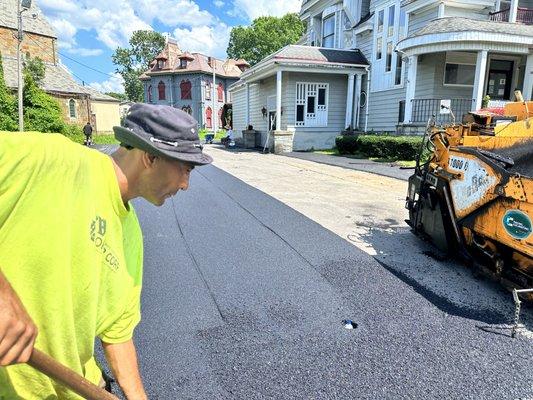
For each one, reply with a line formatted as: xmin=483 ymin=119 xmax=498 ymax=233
xmin=283 ymin=152 xmax=414 ymax=181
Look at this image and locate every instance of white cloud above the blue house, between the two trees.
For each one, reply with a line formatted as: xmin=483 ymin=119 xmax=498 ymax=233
xmin=173 ymin=22 xmax=231 ymax=58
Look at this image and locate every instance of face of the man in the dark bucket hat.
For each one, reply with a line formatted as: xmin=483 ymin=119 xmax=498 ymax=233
xmin=142 ymin=156 xmax=194 ymax=206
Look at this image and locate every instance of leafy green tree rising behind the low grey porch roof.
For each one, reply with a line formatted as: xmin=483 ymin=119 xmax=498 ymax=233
xmin=227 ymin=14 xmax=305 ymax=66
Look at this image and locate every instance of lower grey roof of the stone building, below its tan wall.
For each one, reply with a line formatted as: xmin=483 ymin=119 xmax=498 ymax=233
xmin=2 ymin=56 xmax=120 ymax=102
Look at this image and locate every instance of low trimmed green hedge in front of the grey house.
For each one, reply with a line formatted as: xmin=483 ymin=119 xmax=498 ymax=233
xmin=335 ymin=135 xmax=422 ymax=160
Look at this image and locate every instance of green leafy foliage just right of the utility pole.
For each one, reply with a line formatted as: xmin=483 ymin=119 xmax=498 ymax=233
xmin=23 ymin=74 xmax=66 ymax=133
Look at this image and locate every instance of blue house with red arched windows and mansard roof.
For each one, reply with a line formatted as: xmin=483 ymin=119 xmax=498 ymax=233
xmin=140 ymin=38 xmax=249 ymax=129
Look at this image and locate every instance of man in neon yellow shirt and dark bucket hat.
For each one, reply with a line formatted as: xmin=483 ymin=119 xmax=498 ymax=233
xmin=0 ymin=104 xmax=212 ymax=400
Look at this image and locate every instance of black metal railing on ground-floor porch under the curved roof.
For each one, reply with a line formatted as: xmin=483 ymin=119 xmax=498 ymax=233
xmin=411 ymin=99 xmax=473 ymax=124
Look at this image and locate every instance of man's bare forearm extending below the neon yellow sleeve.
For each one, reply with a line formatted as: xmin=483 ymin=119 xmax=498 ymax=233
xmin=102 ymin=340 xmax=148 ymax=400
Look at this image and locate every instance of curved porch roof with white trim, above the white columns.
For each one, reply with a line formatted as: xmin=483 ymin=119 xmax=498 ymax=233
xmin=396 ymin=17 xmax=533 ymax=55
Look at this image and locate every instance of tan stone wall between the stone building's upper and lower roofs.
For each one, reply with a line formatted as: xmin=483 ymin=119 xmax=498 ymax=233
xmin=0 ymin=27 xmax=57 ymax=63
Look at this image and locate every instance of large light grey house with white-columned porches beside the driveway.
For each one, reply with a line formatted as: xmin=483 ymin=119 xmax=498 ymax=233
xmin=230 ymin=0 xmax=533 ymax=150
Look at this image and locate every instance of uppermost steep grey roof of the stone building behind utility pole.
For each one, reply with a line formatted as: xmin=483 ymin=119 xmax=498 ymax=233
xmin=0 ymin=0 xmax=57 ymax=38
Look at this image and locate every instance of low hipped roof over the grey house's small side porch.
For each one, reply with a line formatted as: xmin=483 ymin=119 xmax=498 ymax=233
xmin=230 ymin=45 xmax=369 ymax=89
